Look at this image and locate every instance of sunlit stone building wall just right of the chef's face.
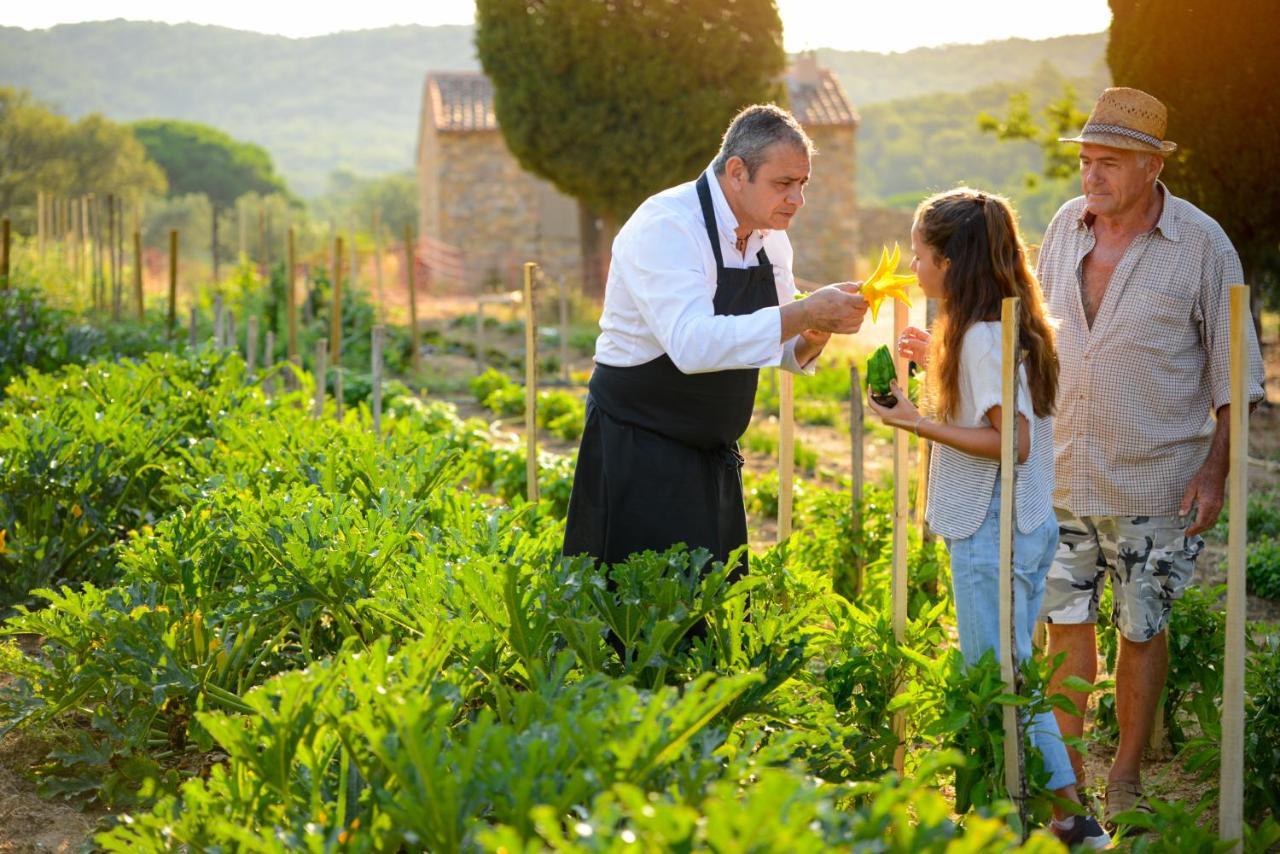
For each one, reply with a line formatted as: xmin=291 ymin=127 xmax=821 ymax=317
xmin=787 ymin=125 xmax=858 ymax=284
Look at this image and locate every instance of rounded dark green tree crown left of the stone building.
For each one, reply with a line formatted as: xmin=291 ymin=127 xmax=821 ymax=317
xmin=132 ymin=119 xmax=285 ymax=207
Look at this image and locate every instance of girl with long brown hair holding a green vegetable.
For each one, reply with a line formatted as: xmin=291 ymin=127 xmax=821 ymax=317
xmin=868 ymin=188 xmax=1111 ymax=849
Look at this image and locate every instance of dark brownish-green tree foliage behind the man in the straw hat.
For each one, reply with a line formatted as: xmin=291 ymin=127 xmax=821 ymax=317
xmin=1107 ymin=0 xmax=1280 ymax=293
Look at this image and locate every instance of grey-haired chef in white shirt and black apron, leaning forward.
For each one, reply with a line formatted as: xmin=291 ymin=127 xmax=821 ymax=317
xmin=564 ymin=105 xmax=867 ymax=591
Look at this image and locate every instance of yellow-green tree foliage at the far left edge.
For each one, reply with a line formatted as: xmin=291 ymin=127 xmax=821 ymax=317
xmin=0 ymin=87 xmax=165 ymax=218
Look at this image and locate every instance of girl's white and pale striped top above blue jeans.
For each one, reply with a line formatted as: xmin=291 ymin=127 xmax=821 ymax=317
xmin=924 ymin=321 xmax=1053 ymax=539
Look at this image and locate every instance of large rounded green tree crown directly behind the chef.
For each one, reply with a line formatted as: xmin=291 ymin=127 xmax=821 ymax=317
xmin=476 ymin=0 xmax=786 ymax=222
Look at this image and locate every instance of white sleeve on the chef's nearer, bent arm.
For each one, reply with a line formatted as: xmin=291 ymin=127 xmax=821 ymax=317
xmin=612 ymin=215 xmax=795 ymax=374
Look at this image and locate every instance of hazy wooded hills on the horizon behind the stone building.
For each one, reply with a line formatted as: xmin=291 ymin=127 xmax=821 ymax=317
xmin=0 ymin=20 xmax=1106 ymax=204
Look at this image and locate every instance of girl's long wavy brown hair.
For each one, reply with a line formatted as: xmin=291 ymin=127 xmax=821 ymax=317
xmin=915 ymin=187 xmax=1057 ymax=420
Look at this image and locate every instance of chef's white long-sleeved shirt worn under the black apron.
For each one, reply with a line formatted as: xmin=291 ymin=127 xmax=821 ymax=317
xmin=595 ymin=166 xmax=814 ymax=374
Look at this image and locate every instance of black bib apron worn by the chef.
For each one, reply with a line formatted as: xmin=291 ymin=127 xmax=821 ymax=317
xmin=564 ymin=174 xmax=778 ymax=579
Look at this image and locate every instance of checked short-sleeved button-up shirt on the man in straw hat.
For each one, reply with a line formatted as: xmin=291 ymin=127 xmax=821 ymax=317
xmin=1038 ymin=182 xmax=1263 ymax=516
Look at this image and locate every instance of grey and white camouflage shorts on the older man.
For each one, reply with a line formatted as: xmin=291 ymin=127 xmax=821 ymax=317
xmin=1041 ymin=507 xmax=1204 ymax=643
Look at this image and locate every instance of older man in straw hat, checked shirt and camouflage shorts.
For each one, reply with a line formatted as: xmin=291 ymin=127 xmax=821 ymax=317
xmin=1039 ymin=88 xmax=1262 ymax=828
